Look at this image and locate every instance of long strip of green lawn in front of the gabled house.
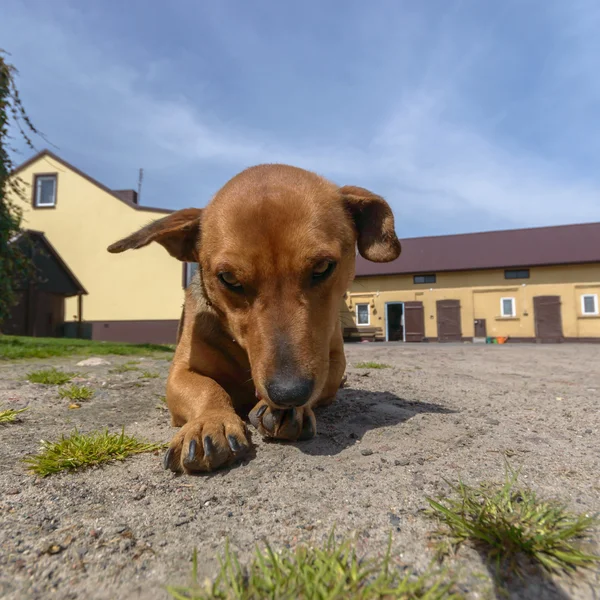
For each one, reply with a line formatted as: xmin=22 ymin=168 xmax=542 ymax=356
xmin=0 ymin=335 xmax=175 ymax=360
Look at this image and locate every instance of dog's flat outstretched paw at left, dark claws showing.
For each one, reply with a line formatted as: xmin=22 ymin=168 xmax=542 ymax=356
xmin=164 ymin=411 xmax=250 ymax=473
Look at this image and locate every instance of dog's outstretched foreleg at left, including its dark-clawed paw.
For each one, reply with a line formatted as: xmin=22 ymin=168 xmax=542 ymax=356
xmin=164 ymin=366 xmax=250 ymax=473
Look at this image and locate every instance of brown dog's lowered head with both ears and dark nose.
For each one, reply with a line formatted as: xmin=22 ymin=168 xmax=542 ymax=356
xmin=109 ymin=165 xmax=400 ymax=407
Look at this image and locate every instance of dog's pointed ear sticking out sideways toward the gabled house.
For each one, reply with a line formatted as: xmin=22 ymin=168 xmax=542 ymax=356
xmin=108 ymin=208 xmax=202 ymax=262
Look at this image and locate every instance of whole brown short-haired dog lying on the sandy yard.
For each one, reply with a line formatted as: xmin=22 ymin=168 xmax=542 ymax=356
xmin=108 ymin=165 xmax=400 ymax=473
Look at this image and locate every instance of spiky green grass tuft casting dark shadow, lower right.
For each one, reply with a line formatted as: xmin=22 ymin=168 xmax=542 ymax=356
xmin=427 ymin=466 xmax=600 ymax=574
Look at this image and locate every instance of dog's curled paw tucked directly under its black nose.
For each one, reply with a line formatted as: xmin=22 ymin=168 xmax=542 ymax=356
xmin=248 ymin=400 xmax=317 ymax=442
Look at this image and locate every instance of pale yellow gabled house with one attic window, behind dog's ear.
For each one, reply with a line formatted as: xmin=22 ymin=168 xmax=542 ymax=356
xmin=5 ymin=150 xmax=192 ymax=343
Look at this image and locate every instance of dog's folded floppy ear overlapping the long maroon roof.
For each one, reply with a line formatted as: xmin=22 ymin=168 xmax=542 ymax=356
xmin=340 ymin=185 xmax=401 ymax=262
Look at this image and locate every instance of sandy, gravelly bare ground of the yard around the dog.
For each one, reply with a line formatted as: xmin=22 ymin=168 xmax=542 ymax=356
xmin=0 ymin=344 xmax=600 ymax=600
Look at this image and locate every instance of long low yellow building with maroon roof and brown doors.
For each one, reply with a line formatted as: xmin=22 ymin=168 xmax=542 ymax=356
xmin=342 ymin=223 xmax=600 ymax=343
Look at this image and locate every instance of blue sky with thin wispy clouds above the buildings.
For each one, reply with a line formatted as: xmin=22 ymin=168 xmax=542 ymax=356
xmin=0 ymin=0 xmax=600 ymax=237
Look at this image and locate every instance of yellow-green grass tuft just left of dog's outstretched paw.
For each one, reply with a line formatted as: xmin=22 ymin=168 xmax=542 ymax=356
xmin=23 ymin=428 xmax=166 ymax=477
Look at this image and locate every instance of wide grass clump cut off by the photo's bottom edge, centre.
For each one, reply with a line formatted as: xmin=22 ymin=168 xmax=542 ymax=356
xmin=167 ymin=532 xmax=461 ymax=600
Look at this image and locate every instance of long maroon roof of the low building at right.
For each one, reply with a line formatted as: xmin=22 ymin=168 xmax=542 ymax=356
xmin=356 ymin=223 xmax=600 ymax=277
